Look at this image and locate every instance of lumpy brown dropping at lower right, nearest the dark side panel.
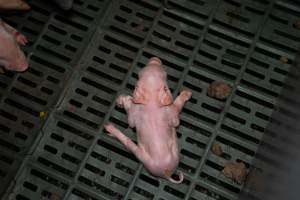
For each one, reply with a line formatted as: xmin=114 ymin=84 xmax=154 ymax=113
xmin=222 ymin=162 xmax=247 ymax=184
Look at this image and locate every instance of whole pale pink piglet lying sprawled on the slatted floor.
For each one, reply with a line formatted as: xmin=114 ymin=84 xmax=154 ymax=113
xmin=105 ymin=57 xmax=192 ymax=183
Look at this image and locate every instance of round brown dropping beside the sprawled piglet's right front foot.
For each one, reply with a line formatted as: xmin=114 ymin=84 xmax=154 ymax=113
xmin=207 ymin=81 xmax=232 ymax=99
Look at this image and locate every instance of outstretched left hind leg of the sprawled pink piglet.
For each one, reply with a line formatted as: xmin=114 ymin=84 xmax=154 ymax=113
xmin=104 ymin=124 xmax=146 ymax=162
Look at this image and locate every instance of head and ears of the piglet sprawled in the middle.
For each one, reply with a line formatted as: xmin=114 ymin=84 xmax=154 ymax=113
xmin=133 ymin=57 xmax=173 ymax=106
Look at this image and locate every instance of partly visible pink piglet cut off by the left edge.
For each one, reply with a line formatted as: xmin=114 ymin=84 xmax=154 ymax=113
xmin=0 ymin=19 xmax=28 ymax=72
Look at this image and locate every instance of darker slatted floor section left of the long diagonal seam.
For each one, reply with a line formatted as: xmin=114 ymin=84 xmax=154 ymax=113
xmin=0 ymin=1 xmax=110 ymax=194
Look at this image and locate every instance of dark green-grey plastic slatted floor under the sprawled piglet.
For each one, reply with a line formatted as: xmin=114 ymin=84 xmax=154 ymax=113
xmin=0 ymin=0 xmax=300 ymax=200
